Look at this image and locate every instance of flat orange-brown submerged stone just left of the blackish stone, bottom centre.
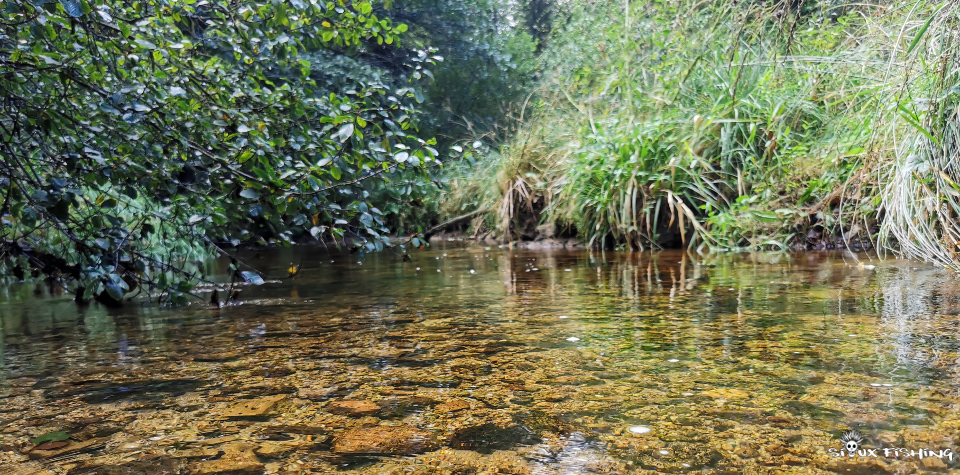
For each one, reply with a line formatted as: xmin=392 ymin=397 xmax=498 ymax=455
xmin=333 ymin=426 xmax=440 ymax=455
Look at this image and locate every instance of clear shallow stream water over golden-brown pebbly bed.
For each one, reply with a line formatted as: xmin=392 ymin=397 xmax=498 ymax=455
xmin=0 ymin=248 xmax=960 ymax=474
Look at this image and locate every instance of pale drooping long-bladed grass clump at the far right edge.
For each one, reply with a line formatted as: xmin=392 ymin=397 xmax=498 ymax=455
xmin=881 ymin=2 xmax=960 ymax=270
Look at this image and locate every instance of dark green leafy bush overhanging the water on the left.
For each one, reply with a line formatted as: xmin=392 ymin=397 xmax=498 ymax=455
xmin=0 ymin=0 xmax=438 ymax=303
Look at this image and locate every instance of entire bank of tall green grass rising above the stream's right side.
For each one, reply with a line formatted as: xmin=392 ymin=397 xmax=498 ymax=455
xmin=452 ymin=0 xmax=960 ymax=269
